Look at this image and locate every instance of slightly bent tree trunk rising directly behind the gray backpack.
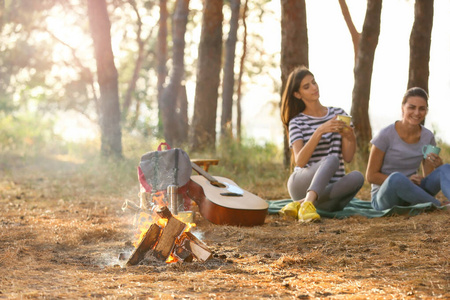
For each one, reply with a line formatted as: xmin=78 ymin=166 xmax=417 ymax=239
xmin=161 ymin=0 xmax=189 ymax=146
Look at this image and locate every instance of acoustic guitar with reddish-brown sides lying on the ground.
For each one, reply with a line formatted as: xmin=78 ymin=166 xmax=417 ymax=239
xmin=187 ymin=163 xmax=269 ymax=226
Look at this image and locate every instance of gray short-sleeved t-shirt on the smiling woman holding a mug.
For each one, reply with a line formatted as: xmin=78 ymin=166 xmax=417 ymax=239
xmin=370 ymin=123 xmax=436 ymax=196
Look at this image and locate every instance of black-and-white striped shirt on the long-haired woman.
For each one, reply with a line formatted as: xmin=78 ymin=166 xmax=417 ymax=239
xmin=289 ymin=106 xmax=348 ymax=182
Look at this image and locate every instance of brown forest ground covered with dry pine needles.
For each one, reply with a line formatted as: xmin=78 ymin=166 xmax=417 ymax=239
xmin=0 ymin=154 xmax=450 ymax=299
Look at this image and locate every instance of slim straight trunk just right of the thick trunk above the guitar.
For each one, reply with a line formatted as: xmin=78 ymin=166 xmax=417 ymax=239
xmin=220 ymin=0 xmax=241 ymax=138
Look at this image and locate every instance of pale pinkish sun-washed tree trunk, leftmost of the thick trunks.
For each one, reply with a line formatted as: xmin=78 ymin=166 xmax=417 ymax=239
xmin=87 ymin=0 xmax=122 ymax=157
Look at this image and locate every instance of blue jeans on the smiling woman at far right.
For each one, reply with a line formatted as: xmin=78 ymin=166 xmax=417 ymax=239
xmin=372 ymin=164 xmax=450 ymax=210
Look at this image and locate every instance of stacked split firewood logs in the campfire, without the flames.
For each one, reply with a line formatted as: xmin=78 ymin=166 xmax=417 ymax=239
xmin=126 ymin=206 xmax=211 ymax=266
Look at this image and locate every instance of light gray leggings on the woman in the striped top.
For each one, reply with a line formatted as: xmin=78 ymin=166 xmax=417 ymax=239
xmin=287 ymin=155 xmax=364 ymax=211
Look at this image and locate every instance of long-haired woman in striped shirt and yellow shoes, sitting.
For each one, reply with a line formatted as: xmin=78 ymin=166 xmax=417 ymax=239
xmin=281 ymin=67 xmax=364 ymax=222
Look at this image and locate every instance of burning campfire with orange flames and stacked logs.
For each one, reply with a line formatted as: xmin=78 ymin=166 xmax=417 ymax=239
xmin=122 ymin=192 xmax=211 ymax=266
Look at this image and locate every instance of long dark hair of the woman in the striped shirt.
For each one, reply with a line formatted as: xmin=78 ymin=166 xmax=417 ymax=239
xmin=281 ymin=66 xmax=314 ymax=132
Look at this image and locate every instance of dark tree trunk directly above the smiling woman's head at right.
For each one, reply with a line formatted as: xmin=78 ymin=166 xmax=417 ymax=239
xmin=408 ymin=0 xmax=434 ymax=92
